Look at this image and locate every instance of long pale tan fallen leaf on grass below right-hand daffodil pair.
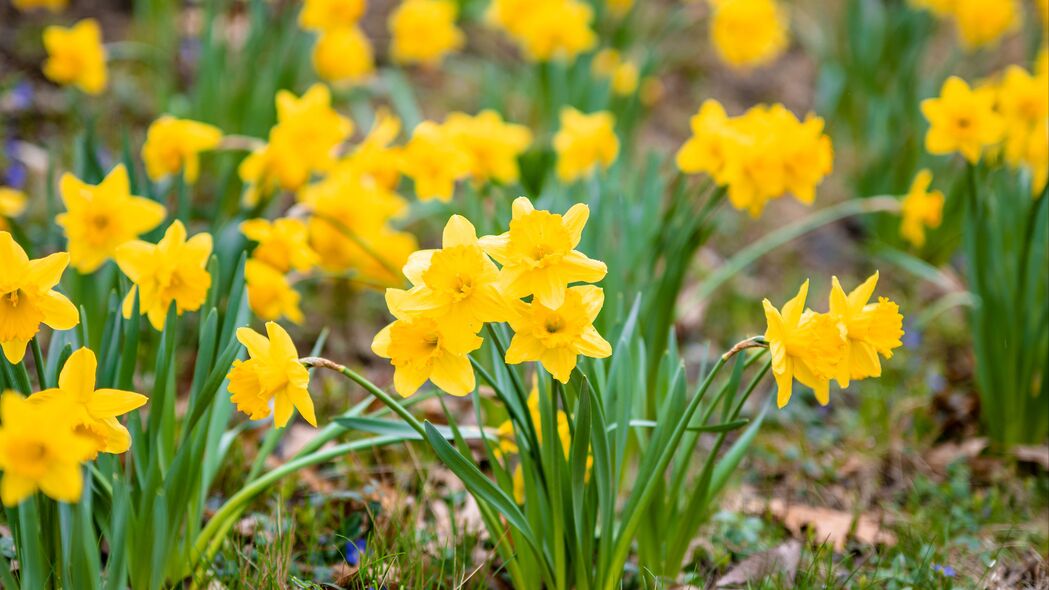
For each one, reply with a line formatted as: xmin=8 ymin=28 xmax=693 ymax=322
xmin=769 ymin=499 xmax=896 ymax=552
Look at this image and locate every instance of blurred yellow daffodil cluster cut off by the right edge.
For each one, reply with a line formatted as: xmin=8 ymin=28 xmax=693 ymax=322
xmin=921 ymin=66 xmax=1049 ymax=195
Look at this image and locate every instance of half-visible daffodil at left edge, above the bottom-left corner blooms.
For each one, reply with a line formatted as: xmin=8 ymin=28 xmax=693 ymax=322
xmin=0 ymin=231 xmax=80 ymax=364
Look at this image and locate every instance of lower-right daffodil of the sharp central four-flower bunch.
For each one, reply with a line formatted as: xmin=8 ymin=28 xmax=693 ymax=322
xmin=506 ymin=285 xmax=612 ymax=383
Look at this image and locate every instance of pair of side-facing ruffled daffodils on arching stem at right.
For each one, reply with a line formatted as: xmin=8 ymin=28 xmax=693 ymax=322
xmin=763 ymin=273 xmax=903 ymax=407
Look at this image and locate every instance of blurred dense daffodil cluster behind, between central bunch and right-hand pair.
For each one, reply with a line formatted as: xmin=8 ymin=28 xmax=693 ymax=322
xmin=677 ymin=100 xmax=833 ymax=217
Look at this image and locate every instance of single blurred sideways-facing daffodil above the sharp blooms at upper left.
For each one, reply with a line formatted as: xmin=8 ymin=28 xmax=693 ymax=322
xmin=142 ymin=114 xmax=222 ymax=184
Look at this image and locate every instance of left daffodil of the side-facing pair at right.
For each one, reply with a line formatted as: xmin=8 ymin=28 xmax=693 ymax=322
xmin=762 ymin=280 xmax=845 ymax=407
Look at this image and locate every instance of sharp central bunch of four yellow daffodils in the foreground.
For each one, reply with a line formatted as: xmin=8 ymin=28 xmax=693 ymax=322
xmin=371 ymin=197 xmax=612 ymax=396
